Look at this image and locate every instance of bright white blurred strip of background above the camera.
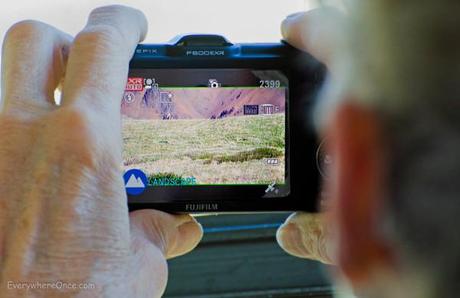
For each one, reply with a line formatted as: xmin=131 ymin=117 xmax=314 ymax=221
xmin=0 ymin=0 xmax=341 ymax=43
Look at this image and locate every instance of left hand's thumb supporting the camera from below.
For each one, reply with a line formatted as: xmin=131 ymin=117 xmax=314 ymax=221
xmin=130 ymin=210 xmax=203 ymax=259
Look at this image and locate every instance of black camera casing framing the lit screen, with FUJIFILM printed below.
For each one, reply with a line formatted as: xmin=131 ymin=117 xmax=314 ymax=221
xmin=128 ymin=46 xmax=325 ymax=213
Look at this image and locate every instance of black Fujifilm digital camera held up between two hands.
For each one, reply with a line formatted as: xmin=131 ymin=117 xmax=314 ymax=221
xmin=121 ymin=35 xmax=326 ymax=213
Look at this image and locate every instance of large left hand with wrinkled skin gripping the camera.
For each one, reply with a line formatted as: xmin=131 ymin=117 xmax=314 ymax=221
xmin=0 ymin=6 xmax=202 ymax=297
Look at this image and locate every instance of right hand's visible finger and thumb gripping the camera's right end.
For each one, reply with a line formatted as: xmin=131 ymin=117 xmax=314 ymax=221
xmin=277 ymin=8 xmax=344 ymax=264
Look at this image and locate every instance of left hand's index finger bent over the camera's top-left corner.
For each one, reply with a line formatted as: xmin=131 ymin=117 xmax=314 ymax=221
xmin=62 ymin=5 xmax=147 ymax=115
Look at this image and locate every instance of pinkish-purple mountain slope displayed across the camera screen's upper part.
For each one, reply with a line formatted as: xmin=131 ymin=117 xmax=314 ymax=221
xmin=121 ymin=88 xmax=286 ymax=119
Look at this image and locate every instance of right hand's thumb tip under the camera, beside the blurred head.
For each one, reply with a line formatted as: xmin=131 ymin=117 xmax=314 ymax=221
xmin=276 ymin=212 xmax=332 ymax=264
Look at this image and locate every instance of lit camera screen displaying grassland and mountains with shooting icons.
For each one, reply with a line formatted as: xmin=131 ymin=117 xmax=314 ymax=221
xmin=121 ymin=69 xmax=288 ymax=187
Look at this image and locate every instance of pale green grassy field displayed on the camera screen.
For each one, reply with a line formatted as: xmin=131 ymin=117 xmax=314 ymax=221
xmin=123 ymin=114 xmax=285 ymax=184
